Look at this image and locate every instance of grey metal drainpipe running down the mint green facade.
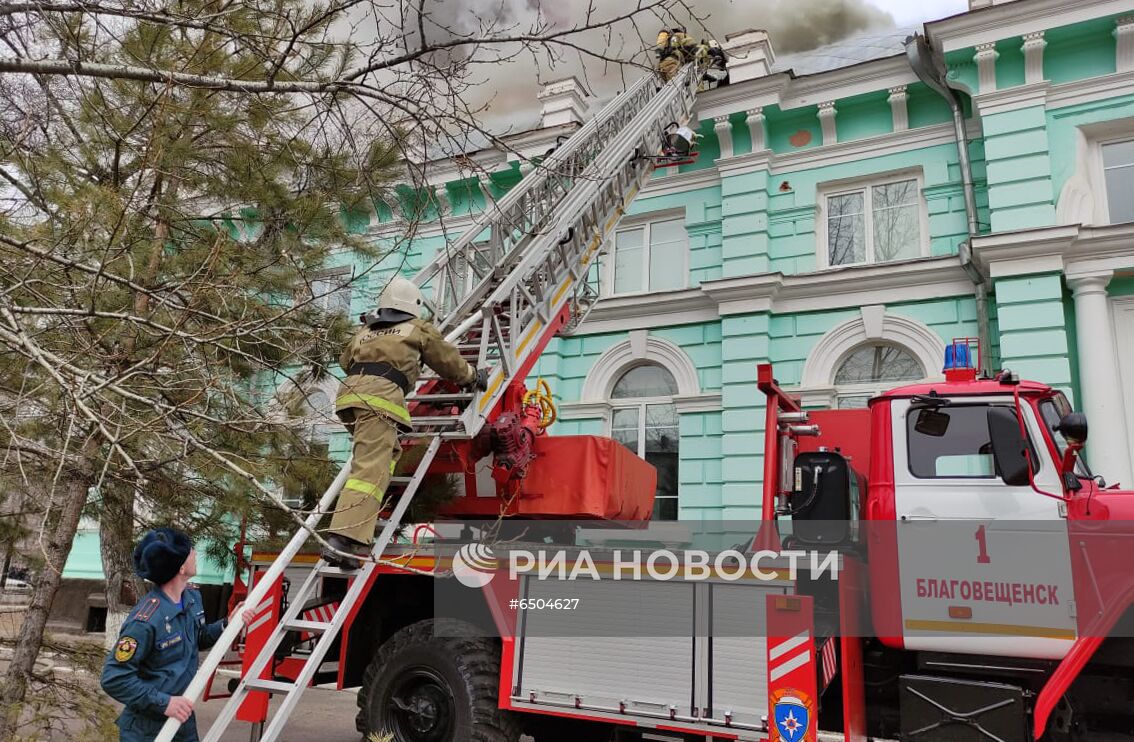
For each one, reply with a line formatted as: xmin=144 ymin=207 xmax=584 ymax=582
xmin=906 ymin=33 xmax=992 ymax=374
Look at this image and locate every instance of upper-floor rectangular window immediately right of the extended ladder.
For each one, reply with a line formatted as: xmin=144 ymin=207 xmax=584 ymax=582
xmin=613 ymin=219 xmax=688 ymax=294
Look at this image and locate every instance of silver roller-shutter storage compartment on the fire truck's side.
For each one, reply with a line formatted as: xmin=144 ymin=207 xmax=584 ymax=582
xmin=513 ymin=571 xmax=794 ymax=730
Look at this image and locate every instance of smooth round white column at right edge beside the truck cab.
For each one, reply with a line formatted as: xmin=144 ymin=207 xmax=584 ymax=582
xmin=1067 ymin=271 xmax=1134 ymax=488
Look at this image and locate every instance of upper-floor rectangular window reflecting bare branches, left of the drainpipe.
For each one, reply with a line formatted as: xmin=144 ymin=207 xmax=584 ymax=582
xmin=824 ymin=178 xmax=925 ymax=267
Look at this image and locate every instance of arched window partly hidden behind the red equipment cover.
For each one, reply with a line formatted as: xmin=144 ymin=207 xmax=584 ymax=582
xmin=610 ymin=363 xmax=680 ymax=521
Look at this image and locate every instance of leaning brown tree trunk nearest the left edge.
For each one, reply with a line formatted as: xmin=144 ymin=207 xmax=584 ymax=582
xmin=0 ymin=465 xmax=96 ymax=740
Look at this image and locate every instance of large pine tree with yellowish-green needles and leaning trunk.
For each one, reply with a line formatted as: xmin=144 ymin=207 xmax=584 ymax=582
xmin=0 ymin=0 xmax=397 ymax=739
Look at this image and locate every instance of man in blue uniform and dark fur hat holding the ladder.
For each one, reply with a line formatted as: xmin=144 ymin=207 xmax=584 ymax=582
xmin=102 ymin=529 xmax=240 ymax=742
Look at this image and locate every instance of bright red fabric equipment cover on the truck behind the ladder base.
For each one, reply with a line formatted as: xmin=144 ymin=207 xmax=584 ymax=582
xmin=516 ymin=436 xmax=658 ymax=521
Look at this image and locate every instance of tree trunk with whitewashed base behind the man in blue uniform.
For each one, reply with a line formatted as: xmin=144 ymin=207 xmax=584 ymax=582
xmin=99 ymin=484 xmax=139 ymax=650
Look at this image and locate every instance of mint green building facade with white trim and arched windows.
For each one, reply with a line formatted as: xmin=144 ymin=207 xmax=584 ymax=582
xmin=57 ymin=0 xmax=1134 ymax=585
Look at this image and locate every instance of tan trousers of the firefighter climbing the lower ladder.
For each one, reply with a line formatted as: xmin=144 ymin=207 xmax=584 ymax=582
xmin=329 ymin=408 xmax=401 ymax=545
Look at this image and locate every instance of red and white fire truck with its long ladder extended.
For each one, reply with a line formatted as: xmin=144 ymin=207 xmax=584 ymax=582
xmin=158 ymin=65 xmax=1134 ymax=742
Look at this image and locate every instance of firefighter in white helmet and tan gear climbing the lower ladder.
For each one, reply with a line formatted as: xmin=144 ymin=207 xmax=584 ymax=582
xmin=323 ymin=277 xmax=488 ymax=568
